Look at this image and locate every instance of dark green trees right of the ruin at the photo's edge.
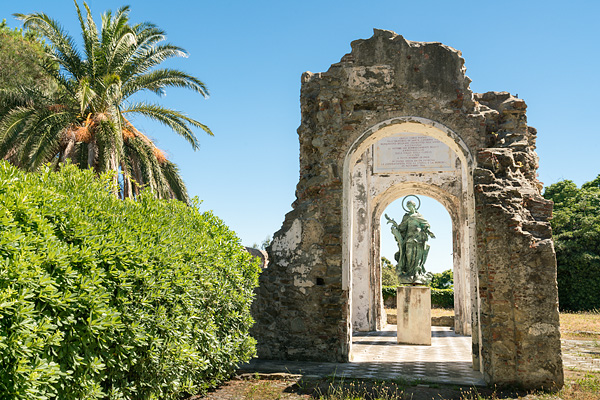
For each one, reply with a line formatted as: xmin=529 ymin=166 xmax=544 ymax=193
xmin=544 ymin=175 xmax=600 ymax=311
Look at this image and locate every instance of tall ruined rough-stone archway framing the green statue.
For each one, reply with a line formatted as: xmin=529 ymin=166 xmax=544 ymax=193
xmin=253 ymin=30 xmax=563 ymax=388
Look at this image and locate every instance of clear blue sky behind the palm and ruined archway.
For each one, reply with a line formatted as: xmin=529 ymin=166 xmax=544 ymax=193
xmin=0 ymin=0 xmax=600 ymax=271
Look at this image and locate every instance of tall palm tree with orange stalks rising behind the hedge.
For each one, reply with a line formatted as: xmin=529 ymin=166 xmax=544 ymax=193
xmin=0 ymin=0 xmax=212 ymax=202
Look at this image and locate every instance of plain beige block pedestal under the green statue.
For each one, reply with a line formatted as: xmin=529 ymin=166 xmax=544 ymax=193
xmin=396 ymin=286 xmax=431 ymax=346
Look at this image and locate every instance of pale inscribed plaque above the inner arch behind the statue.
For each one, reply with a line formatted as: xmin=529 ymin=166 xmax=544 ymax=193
xmin=373 ymin=133 xmax=454 ymax=173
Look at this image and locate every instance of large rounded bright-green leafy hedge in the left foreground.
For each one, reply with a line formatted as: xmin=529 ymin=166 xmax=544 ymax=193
xmin=0 ymin=162 xmax=259 ymax=400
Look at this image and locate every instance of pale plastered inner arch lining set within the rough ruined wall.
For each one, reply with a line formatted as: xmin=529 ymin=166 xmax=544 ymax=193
xmin=343 ymin=117 xmax=480 ymax=370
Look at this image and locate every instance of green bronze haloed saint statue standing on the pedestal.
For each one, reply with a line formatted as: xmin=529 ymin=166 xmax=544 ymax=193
xmin=385 ymin=200 xmax=435 ymax=284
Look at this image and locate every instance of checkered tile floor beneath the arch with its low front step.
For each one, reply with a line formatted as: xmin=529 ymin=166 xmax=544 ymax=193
xmin=240 ymin=325 xmax=485 ymax=386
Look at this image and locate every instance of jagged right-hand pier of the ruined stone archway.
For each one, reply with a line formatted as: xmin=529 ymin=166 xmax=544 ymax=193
xmin=474 ymin=92 xmax=563 ymax=388
